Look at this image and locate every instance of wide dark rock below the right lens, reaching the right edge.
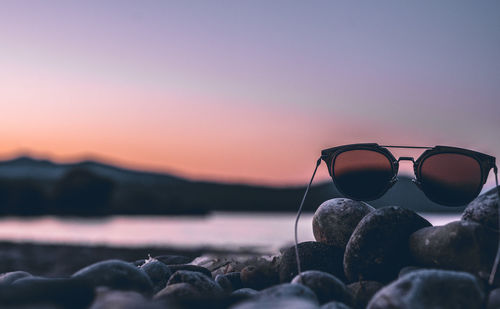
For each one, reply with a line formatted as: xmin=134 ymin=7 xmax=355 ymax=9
xmin=410 ymin=221 xmax=498 ymax=278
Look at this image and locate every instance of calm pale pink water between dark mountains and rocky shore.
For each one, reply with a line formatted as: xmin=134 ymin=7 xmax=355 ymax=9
xmin=0 ymin=213 xmax=460 ymax=251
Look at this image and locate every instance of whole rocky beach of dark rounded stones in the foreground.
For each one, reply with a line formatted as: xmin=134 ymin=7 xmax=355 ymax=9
xmin=0 ymin=185 xmax=500 ymax=309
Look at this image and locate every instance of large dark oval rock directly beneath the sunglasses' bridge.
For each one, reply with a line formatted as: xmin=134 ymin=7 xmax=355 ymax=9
xmin=344 ymin=206 xmax=431 ymax=282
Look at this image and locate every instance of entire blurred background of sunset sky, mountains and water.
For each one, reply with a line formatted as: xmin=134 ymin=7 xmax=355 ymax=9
xmin=0 ymin=0 xmax=500 ymax=258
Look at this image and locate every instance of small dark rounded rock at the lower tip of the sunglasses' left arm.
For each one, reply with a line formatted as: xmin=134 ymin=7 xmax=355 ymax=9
xmin=292 ymin=270 xmax=352 ymax=305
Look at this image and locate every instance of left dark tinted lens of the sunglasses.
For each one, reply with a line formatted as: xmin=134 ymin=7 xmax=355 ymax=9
xmin=332 ymin=150 xmax=393 ymax=200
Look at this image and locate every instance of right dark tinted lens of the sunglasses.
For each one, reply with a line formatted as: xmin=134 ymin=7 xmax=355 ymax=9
xmin=419 ymin=153 xmax=482 ymax=206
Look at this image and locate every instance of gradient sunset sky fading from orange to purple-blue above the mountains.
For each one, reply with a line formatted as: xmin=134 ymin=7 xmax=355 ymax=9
xmin=0 ymin=0 xmax=500 ymax=185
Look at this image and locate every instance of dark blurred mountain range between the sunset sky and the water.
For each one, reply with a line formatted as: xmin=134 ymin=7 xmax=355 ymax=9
xmin=0 ymin=157 xmax=463 ymax=216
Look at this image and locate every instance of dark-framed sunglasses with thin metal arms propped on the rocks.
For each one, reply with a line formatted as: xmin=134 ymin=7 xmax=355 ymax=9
xmin=295 ymin=143 xmax=500 ymax=284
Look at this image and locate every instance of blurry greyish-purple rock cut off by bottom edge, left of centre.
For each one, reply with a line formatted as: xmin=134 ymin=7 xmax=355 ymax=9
xmin=90 ymin=288 xmax=162 ymax=309
